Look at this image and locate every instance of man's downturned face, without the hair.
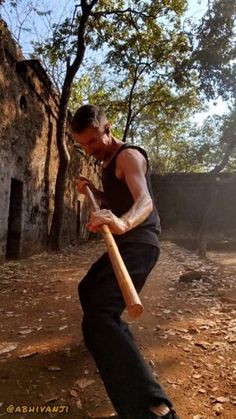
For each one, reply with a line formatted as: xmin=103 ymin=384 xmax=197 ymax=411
xmin=72 ymin=126 xmax=110 ymax=161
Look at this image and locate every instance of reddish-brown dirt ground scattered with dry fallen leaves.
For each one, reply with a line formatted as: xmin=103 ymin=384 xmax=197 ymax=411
xmin=0 ymin=242 xmax=236 ymax=419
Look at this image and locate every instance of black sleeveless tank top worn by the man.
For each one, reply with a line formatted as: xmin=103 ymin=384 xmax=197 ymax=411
xmin=102 ymin=143 xmax=161 ymax=247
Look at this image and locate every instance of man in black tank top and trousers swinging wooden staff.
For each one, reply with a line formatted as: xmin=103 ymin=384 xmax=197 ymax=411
xmin=72 ymin=105 xmax=178 ymax=419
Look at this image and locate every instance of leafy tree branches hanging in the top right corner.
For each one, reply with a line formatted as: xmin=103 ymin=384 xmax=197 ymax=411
xmin=178 ymin=0 xmax=236 ymax=100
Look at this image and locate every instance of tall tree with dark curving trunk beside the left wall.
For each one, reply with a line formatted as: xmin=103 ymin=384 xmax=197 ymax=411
xmin=38 ymin=0 xmax=196 ymax=249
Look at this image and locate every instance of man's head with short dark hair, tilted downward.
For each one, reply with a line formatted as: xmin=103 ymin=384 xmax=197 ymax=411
xmin=71 ymin=105 xmax=111 ymax=161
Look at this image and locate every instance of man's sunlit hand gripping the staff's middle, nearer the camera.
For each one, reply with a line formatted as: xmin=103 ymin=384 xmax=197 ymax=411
xmin=87 ymin=209 xmax=127 ymax=234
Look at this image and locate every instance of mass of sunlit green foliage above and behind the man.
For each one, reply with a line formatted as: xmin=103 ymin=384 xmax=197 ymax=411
xmin=8 ymin=0 xmax=236 ymax=173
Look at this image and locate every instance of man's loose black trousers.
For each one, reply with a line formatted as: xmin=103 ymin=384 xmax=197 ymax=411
xmin=79 ymin=243 xmax=172 ymax=419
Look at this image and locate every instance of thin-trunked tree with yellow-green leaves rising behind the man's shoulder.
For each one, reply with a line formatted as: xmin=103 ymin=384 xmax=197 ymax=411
xmin=87 ymin=0 xmax=194 ymax=141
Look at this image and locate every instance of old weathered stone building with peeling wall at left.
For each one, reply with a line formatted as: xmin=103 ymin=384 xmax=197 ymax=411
xmin=0 ymin=25 xmax=97 ymax=258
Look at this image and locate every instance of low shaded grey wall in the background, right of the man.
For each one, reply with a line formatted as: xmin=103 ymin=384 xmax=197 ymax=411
xmin=152 ymin=173 xmax=236 ymax=240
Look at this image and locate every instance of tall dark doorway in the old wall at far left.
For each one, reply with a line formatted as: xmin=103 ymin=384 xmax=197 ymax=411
xmin=6 ymin=178 xmax=23 ymax=259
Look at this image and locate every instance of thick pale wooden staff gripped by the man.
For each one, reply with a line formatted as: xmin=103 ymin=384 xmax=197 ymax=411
xmin=85 ymin=185 xmax=143 ymax=317
